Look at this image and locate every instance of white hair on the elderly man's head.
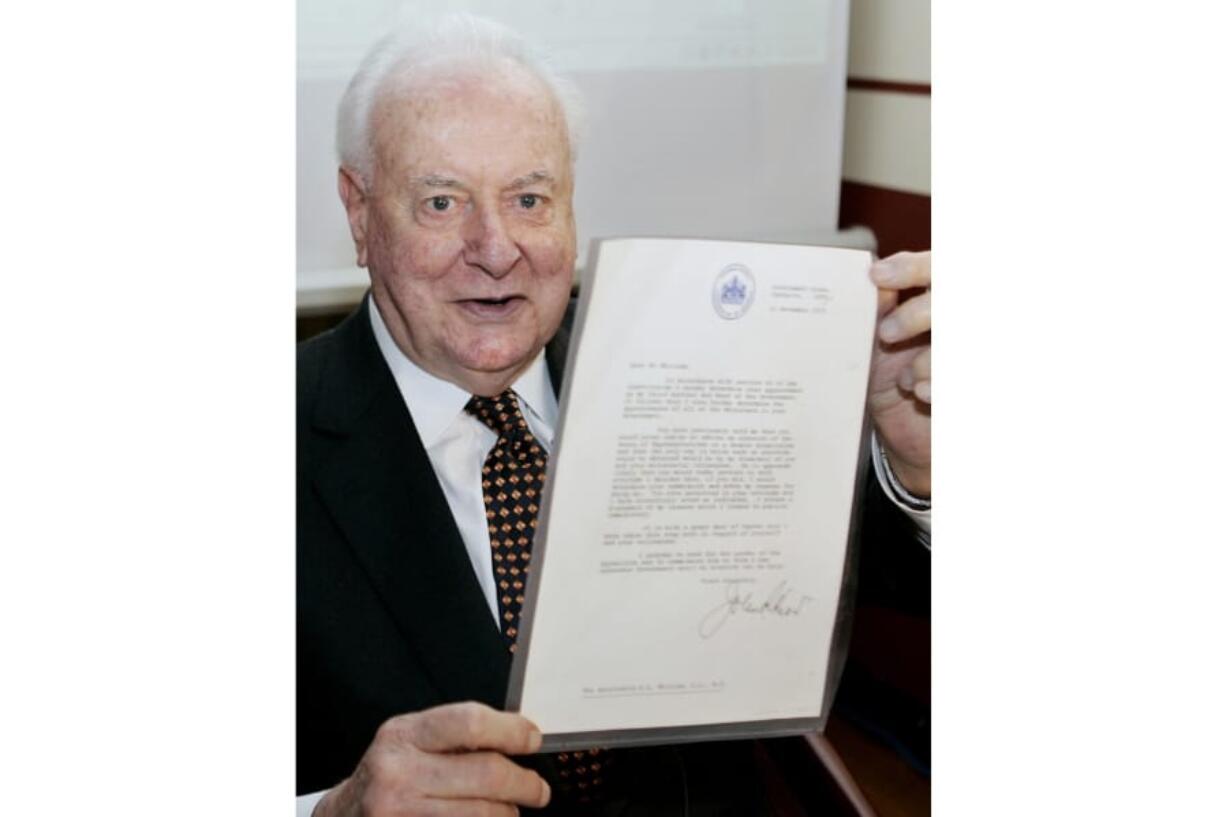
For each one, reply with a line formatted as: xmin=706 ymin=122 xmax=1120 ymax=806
xmin=336 ymin=13 xmax=584 ymax=182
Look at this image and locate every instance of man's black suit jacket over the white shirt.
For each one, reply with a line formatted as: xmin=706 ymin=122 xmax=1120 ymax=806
xmin=297 ymin=298 xmax=921 ymax=815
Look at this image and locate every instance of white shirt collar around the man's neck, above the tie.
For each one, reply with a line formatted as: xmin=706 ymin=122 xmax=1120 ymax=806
xmin=369 ymin=298 xmax=558 ymax=448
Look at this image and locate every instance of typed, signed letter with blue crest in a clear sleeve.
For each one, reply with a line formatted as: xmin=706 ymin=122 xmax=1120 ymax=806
xmin=508 ymin=239 xmax=877 ymax=748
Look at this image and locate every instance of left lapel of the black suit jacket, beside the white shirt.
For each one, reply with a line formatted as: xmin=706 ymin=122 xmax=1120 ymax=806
xmin=314 ymin=299 xmax=510 ymax=707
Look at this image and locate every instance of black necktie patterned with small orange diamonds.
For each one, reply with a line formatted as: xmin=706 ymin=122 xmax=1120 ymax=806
xmin=465 ymin=389 xmax=613 ymax=802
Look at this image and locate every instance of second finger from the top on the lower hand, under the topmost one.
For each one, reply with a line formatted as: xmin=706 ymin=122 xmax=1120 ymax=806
xmin=423 ymin=752 xmax=549 ymax=808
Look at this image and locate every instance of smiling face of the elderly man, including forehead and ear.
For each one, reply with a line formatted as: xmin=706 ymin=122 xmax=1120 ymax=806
xmin=341 ymin=65 xmax=575 ymax=394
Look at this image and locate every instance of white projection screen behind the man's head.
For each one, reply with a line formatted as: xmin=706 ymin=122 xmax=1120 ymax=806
xmin=297 ymin=0 xmax=848 ymax=290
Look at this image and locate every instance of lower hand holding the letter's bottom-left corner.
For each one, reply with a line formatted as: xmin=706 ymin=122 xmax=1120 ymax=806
xmin=314 ymin=702 xmax=549 ymax=817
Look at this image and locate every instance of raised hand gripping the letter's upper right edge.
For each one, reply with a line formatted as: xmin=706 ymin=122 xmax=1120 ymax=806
xmin=868 ymin=253 xmax=932 ymax=497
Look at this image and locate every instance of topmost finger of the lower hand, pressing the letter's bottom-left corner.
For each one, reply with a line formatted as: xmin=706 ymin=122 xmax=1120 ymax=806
xmin=408 ymin=700 xmax=541 ymax=754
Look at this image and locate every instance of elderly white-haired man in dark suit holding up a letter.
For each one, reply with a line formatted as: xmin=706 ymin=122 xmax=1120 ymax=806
xmin=298 ymin=18 xmax=929 ymax=816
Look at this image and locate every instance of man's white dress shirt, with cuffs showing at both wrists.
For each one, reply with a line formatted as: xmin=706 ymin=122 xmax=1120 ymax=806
xmin=297 ymin=301 xmax=931 ymax=817
